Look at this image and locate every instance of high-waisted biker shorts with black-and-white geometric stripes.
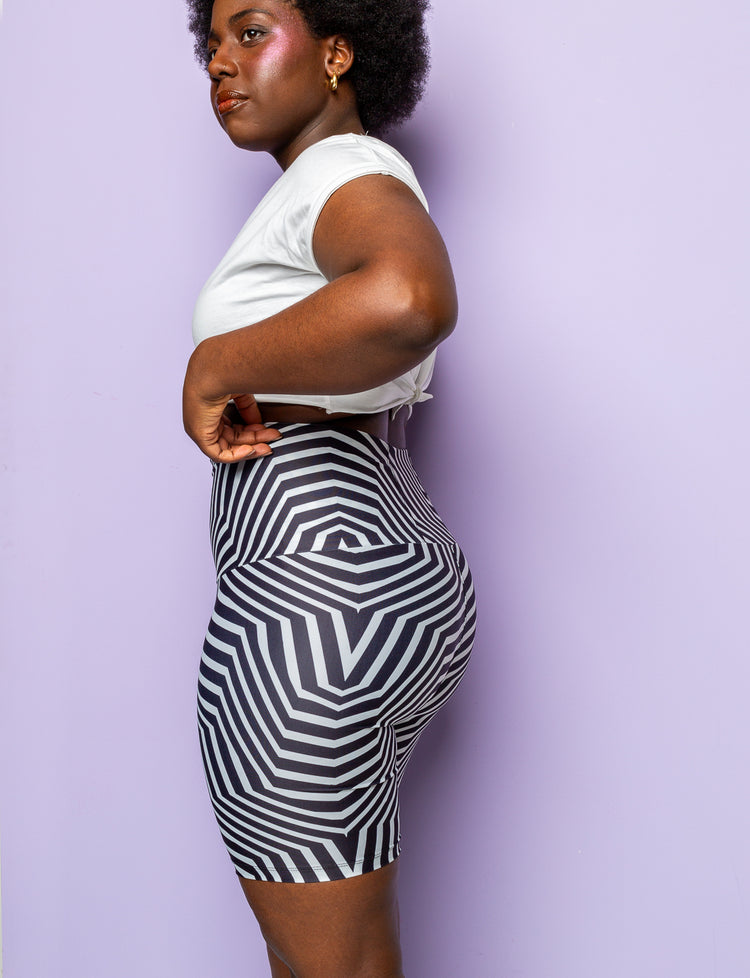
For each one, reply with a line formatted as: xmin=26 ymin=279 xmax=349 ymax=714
xmin=198 ymin=424 xmax=475 ymax=882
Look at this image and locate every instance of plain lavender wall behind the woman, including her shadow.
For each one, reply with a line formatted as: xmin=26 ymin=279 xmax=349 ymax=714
xmin=0 ymin=0 xmax=750 ymax=978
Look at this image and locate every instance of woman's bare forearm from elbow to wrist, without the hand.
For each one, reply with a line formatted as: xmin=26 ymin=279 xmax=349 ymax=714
xmin=188 ymin=262 xmax=456 ymax=399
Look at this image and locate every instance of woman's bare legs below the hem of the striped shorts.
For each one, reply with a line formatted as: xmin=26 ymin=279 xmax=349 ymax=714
xmin=240 ymin=860 xmax=403 ymax=978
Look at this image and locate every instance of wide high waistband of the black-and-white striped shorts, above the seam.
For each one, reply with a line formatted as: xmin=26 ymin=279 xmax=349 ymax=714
xmin=211 ymin=422 xmax=455 ymax=575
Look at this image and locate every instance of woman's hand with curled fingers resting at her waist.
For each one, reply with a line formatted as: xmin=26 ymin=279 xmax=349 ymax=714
xmin=182 ymin=367 xmax=281 ymax=462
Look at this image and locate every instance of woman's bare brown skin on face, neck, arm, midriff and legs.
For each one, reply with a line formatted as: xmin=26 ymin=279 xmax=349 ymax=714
xmin=183 ymin=0 xmax=457 ymax=978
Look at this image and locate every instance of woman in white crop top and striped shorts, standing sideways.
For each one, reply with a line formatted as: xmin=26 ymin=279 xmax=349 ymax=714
xmin=183 ymin=0 xmax=474 ymax=978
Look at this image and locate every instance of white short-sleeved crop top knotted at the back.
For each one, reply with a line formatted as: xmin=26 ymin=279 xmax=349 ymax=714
xmin=193 ymin=133 xmax=435 ymax=414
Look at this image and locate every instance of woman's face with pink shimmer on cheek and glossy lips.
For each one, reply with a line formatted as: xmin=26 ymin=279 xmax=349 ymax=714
xmin=208 ymin=0 xmax=329 ymax=159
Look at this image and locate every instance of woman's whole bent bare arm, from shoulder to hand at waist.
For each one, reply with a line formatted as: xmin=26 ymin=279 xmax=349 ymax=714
xmin=184 ymin=175 xmax=457 ymax=461
